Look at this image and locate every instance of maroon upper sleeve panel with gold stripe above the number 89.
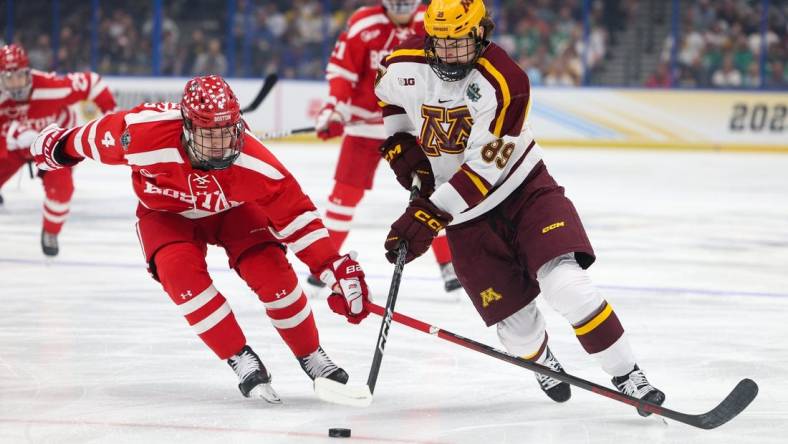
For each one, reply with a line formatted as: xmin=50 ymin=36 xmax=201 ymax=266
xmin=476 ymin=44 xmax=531 ymax=137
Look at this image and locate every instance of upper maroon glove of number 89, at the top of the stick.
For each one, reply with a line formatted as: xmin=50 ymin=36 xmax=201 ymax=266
xmin=379 ymin=133 xmax=435 ymax=197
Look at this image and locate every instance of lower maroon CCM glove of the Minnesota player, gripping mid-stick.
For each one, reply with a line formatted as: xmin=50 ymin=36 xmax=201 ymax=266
xmin=383 ymin=197 xmax=452 ymax=264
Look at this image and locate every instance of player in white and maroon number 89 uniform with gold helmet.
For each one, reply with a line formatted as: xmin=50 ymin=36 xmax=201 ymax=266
xmin=375 ymin=0 xmax=665 ymax=416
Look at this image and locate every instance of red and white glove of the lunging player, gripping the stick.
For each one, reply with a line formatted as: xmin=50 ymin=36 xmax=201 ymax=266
xmin=320 ymin=251 xmax=369 ymax=324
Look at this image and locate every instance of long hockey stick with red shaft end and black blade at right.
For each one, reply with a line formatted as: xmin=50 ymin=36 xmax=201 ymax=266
xmin=369 ymin=303 xmax=758 ymax=430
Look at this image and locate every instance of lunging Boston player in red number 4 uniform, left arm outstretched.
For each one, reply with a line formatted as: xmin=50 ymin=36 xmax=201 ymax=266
xmin=31 ymin=76 xmax=368 ymax=403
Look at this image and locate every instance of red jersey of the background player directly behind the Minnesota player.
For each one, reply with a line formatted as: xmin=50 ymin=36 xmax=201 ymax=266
xmin=326 ymin=5 xmax=426 ymax=139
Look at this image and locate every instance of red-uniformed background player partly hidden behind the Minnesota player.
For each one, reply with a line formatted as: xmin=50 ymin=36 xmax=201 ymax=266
xmin=308 ymin=0 xmax=460 ymax=291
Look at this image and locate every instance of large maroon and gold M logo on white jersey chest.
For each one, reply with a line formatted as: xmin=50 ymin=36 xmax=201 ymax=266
xmin=420 ymin=105 xmax=473 ymax=157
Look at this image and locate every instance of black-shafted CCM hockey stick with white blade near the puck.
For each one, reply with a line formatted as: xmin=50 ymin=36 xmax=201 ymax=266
xmin=315 ymin=180 xmax=420 ymax=407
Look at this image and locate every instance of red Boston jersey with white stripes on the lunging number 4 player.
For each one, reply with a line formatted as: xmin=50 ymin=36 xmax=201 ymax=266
xmin=56 ymin=103 xmax=337 ymax=273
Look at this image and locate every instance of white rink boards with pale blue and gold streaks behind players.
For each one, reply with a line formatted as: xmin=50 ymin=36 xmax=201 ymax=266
xmin=75 ymin=77 xmax=788 ymax=152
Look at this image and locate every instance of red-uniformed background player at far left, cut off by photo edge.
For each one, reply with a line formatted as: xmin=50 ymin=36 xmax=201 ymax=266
xmin=0 ymin=44 xmax=115 ymax=256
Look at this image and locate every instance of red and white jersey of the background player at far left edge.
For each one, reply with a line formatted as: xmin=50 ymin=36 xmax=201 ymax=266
xmin=0 ymin=70 xmax=116 ymax=158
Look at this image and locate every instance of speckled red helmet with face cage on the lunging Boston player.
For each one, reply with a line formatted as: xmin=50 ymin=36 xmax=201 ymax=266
xmin=181 ymin=75 xmax=245 ymax=170
